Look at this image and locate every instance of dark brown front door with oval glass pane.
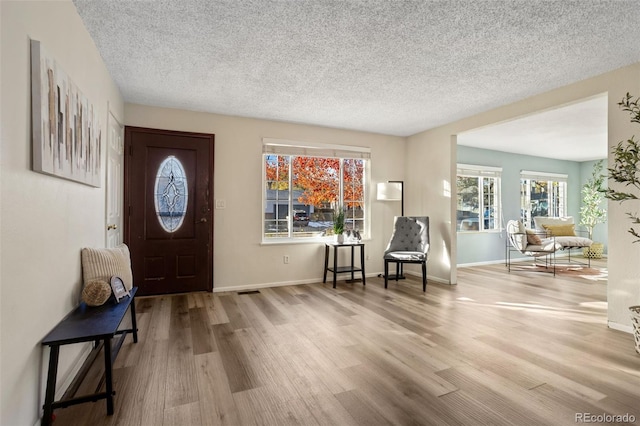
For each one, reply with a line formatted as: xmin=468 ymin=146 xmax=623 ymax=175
xmin=124 ymin=127 xmax=214 ymax=295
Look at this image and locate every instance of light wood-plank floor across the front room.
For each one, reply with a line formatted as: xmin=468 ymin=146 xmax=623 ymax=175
xmin=55 ymin=262 xmax=640 ymax=426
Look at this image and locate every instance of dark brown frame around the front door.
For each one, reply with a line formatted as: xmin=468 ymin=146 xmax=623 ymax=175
xmin=122 ymin=126 xmax=215 ymax=291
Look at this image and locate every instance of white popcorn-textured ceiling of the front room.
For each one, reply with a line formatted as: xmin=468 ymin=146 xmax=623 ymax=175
xmin=74 ymin=0 xmax=640 ymax=149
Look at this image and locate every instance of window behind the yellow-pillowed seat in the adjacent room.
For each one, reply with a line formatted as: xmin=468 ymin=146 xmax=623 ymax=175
xmin=520 ymin=170 xmax=567 ymax=228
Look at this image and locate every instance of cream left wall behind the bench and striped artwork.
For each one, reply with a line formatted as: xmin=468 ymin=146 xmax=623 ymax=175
xmin=0 ymin=1 xmax=124 ymax=425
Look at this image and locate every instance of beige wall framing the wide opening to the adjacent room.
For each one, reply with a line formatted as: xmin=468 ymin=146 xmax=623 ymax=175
xmin=407 ymin=63 xmax=640 ymax=330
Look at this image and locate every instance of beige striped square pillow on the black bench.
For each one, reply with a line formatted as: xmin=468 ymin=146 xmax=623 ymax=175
xmin=82 ymin=244 xmax=133 ymax=290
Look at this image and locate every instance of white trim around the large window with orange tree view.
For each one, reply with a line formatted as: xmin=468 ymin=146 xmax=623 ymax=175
xmin=260 ymin=138 xmax=371 ymax=245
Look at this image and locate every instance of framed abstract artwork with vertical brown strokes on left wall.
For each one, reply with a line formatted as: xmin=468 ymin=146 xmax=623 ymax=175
xmin=31 ymin=40 xmax=102 ymax=187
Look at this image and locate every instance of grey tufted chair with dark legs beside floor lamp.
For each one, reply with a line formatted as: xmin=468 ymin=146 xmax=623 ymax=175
xmin=384 ymin=216 xmax=429 ymax=291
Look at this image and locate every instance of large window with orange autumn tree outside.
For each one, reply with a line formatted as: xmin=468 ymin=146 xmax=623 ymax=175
xmin=263 ymin=139 xmax=370 ymax=241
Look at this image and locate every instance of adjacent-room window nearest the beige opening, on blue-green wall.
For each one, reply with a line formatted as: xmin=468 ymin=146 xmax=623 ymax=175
xmin=456 ymin=164 xmax=502 ymax=231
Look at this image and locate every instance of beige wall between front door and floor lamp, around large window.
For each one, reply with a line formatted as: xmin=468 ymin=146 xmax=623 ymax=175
xmin=125 ymin=104 xmax=406 ymax=291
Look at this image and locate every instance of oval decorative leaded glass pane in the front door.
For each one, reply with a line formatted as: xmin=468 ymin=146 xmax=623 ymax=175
xmin=154 ymin=155 xmax=189 ymax=232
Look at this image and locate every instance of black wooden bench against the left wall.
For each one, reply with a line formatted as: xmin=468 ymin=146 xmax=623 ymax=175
xmin=42 ymin=287 xmax=138 ymax=426
